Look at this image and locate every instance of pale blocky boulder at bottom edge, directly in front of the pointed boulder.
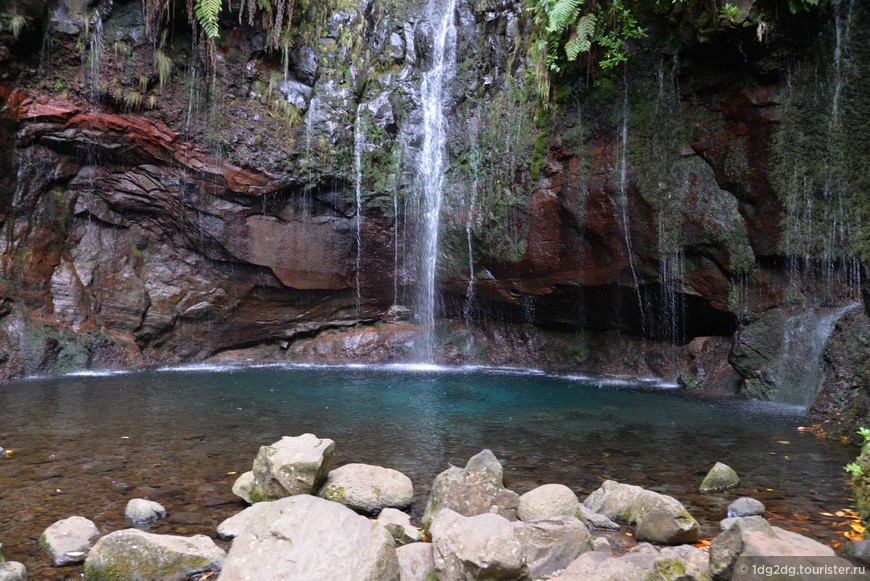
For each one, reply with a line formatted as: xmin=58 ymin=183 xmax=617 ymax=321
xmin=429 ymin=508 xmax=525 ymax=579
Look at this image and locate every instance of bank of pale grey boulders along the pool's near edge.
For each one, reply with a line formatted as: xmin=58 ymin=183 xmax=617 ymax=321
xmin=0 ymin=434 xmax=870 ymax=581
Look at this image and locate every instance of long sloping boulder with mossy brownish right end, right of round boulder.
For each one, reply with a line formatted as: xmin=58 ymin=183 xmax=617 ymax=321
xmin=583 ymin=480 xmax=701 ymax=545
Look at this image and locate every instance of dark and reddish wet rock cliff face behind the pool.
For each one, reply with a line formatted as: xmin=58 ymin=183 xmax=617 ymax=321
xmin=0 ymin=0 xmax=870 ymax=416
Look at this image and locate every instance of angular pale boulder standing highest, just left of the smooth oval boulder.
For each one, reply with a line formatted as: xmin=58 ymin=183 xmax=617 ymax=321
xmin=233 ymin=434 xmax=335 ymax=503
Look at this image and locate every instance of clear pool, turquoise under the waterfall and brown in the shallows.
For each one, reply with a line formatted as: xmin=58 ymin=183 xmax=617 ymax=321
xmin=0 ymin=366 xmax=855 ymax=579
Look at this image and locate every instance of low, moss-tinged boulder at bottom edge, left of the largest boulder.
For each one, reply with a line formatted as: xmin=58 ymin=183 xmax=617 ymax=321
xmin=84 ymin=529 xmax=226 ymax=581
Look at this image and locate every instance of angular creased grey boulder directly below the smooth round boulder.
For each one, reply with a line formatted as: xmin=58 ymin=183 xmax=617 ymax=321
xmin=514 ymin=516 xmax=593 ymax=579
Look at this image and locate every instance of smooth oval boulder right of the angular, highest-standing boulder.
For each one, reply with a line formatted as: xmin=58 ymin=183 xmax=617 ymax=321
xmin=317 ymin=464 xmax=414 ymax=514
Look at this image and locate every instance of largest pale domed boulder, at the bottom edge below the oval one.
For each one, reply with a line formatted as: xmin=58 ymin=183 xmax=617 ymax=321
xmin=220 ymin=495 xmax=399 ymax=581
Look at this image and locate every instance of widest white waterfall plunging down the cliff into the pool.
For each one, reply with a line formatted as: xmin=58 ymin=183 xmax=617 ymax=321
xmin=417 ymin=0 xmax=456 ymax=361
